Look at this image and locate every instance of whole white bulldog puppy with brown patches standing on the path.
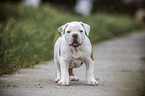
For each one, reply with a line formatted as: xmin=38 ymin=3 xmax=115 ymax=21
xmin=54 ymin=21 xmax=98 ymax=85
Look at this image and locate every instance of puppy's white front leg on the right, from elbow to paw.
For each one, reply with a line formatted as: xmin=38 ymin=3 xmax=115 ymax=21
xmin=85 ymin=58 xmax=98 ymax=86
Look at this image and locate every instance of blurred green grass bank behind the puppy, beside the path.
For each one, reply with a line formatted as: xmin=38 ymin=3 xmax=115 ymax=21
xmin=0 ymin=4 xmax=144 ymax=75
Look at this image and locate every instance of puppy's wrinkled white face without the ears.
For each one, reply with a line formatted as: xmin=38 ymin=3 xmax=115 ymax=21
xmin=64 ymin=22 xmax=85 ymax=48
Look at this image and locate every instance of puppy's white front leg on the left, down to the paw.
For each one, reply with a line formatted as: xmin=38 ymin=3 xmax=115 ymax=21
xmin=58 ymin=57 xmax=69 ymax=86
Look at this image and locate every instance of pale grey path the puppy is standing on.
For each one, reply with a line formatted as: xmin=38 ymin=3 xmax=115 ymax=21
xmin=0 ymin=30 xmax=145 ymax=96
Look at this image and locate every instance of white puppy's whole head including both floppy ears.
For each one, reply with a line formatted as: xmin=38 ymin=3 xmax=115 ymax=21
xmin=58 ymin=21 xmax=90 ymax=48
